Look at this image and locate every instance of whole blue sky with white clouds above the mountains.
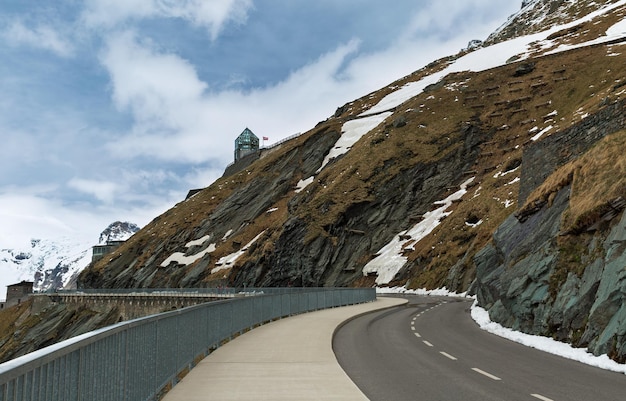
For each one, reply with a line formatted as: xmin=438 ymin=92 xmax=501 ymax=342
xmin=0 ymin=0 xmax=521 ymax=248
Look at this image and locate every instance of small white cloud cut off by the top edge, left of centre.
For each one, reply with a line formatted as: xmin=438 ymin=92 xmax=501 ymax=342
xmin=83 ymin=0 xmax=252 ymax=40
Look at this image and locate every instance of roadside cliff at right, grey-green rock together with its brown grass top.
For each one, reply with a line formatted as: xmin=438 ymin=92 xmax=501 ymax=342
xmin=472 ymin=93 xmax=626 ymax=363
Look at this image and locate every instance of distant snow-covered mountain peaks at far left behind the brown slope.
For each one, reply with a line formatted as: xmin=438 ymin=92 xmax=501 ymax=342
xmin=0 ymin=221 xmax=139 ymax=291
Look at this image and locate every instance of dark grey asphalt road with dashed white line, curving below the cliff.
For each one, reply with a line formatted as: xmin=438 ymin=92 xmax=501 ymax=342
xmin=333 ymin=296 xmax=626 ymax=401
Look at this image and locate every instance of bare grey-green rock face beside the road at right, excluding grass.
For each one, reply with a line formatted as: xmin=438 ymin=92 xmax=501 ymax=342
xmin=472 ymin=188 xmax=626 ymax=363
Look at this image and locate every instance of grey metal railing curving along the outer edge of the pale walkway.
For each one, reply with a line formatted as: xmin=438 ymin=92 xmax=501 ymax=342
xmin=0 ymin=288 xmax=376 ymax=401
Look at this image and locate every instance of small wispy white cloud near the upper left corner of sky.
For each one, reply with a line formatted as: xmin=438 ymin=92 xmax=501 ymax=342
xmin=1 ymin=21 xmax=74 ymax=57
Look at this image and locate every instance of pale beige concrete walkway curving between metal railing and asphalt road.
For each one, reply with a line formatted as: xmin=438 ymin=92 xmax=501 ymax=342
xmin=163 ymin=298 xmax=406 ymax=401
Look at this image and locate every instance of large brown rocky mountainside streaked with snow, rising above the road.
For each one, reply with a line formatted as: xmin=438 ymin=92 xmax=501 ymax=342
xmin=79 ymin=0 xmax=626 ymax=362
